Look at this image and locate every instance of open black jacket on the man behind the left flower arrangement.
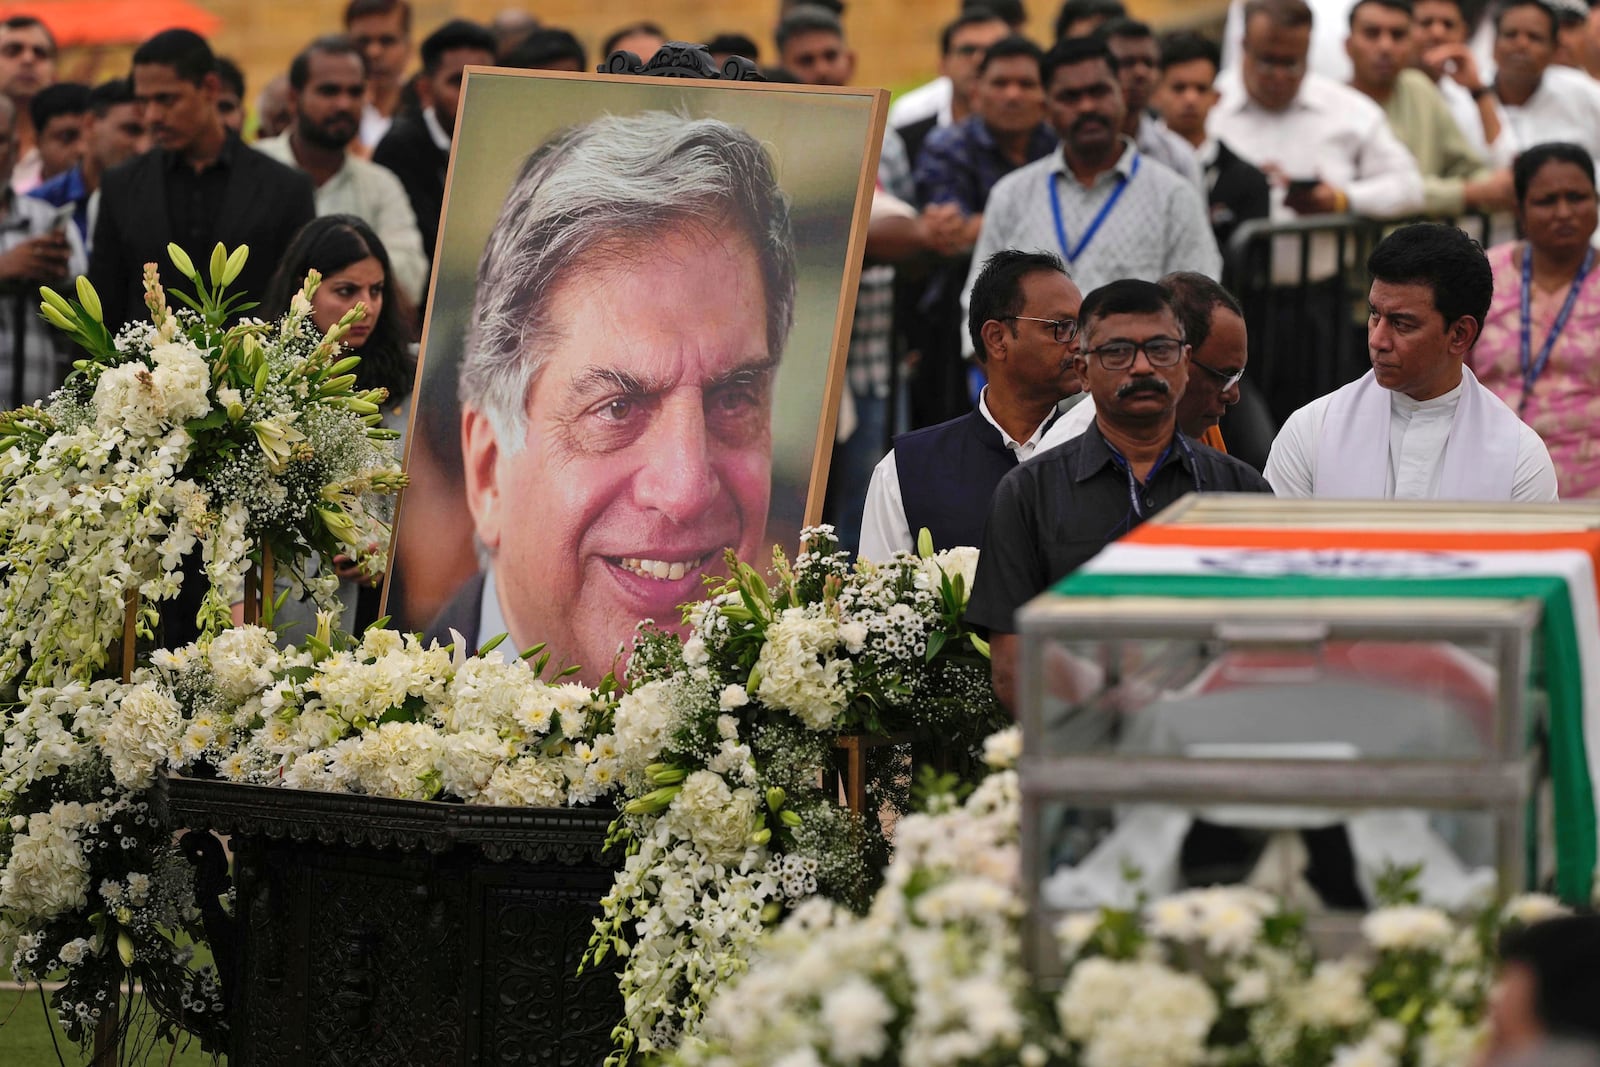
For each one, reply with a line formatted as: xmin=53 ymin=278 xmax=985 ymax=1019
xmin=90 ymin=133 xmax=317 ymax=331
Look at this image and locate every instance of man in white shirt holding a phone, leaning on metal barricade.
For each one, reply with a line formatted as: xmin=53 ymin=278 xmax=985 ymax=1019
xmin=1206 ymin=0 xmax=1422 ymax=218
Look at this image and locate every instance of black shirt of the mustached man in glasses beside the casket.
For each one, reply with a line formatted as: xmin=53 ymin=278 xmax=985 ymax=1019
xmin=966 ymin=422 xmax=1272 ymax=633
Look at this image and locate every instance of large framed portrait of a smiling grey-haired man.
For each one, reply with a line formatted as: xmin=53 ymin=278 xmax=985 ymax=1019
xmin=386 ymin=69 xmax=886 ymax=683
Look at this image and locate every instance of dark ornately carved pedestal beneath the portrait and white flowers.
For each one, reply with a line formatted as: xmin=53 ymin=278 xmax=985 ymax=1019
xmin=168 ymin=779 xmax=622 ymax=1067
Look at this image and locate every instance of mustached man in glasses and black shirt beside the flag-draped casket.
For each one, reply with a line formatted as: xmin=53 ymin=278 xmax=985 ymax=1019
xmin=966 ymin=278 xmax=1272 ymax=709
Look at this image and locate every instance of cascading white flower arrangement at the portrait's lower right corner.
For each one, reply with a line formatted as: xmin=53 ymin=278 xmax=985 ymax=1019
xmin=584 ymin=526 xmax=1003 ymax=1064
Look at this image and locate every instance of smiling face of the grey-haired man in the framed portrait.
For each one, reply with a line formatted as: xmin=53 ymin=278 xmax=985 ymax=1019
xmin=462 ymin=224 xmax=779 ymax=681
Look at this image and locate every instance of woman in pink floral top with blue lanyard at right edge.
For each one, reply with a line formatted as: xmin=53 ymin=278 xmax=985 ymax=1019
xmin=1469 ymin=144 xmax=1600 ymax=499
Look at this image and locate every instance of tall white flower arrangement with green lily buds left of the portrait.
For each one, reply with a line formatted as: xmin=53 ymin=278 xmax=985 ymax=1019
xmin=0 ymin=245 xmax=405 ymax=685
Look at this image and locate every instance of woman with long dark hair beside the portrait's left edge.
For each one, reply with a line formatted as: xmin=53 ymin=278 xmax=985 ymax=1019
xmin=261 ymin=214 xmax=416 ymax=640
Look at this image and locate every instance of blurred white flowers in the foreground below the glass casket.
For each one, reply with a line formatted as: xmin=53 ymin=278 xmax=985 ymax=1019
xmin=667 ymin=733 xmax=1565 ymax=1067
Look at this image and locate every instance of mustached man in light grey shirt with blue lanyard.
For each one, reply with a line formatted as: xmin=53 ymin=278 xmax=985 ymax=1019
xmin=962 ymin=38 xmax=1222 ymax=334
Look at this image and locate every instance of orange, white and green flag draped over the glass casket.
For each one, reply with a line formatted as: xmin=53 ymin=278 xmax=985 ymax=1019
xmin=1053 ymin=522 xmax=1600 ymax=901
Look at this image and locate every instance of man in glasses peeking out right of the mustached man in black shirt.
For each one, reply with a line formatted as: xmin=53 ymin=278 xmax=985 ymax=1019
xmin=1040 ymin=270 xmax=1266 ymax=453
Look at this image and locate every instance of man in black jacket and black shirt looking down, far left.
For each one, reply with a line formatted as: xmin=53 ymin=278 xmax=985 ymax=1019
xmin=90 ymin=29 xmax=317 ymax=331
